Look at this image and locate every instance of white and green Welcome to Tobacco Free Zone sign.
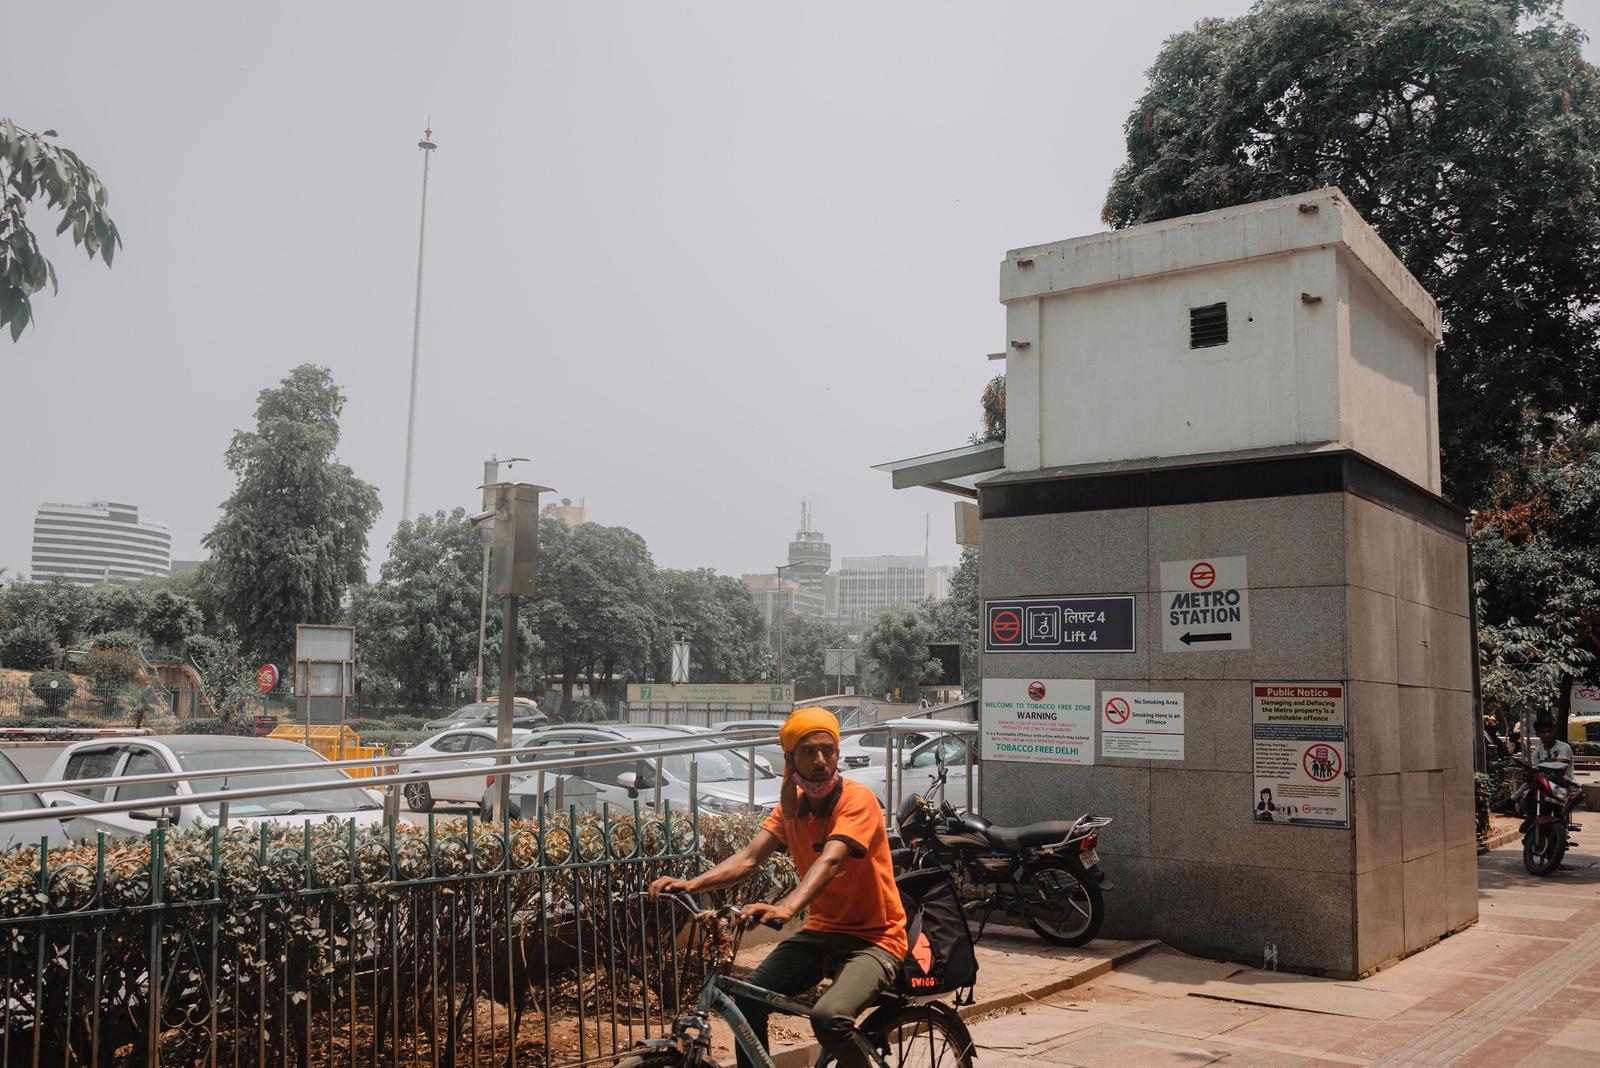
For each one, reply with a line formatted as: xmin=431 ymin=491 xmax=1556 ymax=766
xmin=979 ymin=678 xmax=1096 ymax=764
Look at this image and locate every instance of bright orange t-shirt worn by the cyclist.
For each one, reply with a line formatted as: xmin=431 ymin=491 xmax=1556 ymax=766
xmin=762 ymin=779 xmax=906 ymax=961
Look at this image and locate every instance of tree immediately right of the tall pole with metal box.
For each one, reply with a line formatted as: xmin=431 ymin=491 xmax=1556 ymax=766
xmin=533 ymin=518 xmax=661 ymax=707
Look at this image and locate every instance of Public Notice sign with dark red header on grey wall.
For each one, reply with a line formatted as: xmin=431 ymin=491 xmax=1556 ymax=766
xmin=1250 ymin=683 xmax=1350 ymax=827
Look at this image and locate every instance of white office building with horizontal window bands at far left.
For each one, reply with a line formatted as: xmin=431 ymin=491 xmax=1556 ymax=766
xmin=32 ymin=500 xmax=173 ymax=585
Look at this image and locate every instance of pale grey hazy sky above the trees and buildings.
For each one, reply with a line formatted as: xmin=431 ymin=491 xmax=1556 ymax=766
xmin=0 ymin=0 xmax=1600 ymax=585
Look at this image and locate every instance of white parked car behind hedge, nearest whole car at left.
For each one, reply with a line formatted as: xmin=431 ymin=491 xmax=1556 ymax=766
xmin=42 ymin=734 xmax=384 ymax=838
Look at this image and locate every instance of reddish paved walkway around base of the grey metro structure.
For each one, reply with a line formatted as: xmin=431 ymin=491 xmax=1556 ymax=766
xmin=973 ymin=831 xmax=1600 ymax=1068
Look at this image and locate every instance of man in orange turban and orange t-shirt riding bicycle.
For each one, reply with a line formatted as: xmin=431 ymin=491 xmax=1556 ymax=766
xmin=650 ymin=708 xmax=906 ymax=1068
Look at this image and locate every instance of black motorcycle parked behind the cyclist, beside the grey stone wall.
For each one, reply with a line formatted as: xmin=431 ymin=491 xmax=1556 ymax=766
xmin=894 ymin=761 xmax=1112 ymax=945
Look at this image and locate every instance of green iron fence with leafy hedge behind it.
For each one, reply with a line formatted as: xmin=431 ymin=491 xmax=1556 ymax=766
xmin=0 ymin=809 xmax=794 ymax=1068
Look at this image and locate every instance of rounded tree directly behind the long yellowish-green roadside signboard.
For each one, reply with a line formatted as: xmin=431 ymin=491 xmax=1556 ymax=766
xmin=650 ymin=568 xmax=768 ymax=683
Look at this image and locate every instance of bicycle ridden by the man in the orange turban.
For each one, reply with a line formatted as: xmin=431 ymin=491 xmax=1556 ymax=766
xmin=616 ymin=892 xmax=973 ymax=1068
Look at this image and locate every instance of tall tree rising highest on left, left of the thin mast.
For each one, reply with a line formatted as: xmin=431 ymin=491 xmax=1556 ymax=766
xmin=205 ymin=365 xmax=379 ymax=664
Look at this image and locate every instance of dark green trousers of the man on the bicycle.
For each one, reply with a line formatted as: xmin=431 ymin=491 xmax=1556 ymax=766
xmin=736 ymin=931 xmax=899 ymax=1068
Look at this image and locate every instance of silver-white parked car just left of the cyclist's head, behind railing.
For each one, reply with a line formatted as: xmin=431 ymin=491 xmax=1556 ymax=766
xmin=492 ymin=723 xmax=781 ymax=815
